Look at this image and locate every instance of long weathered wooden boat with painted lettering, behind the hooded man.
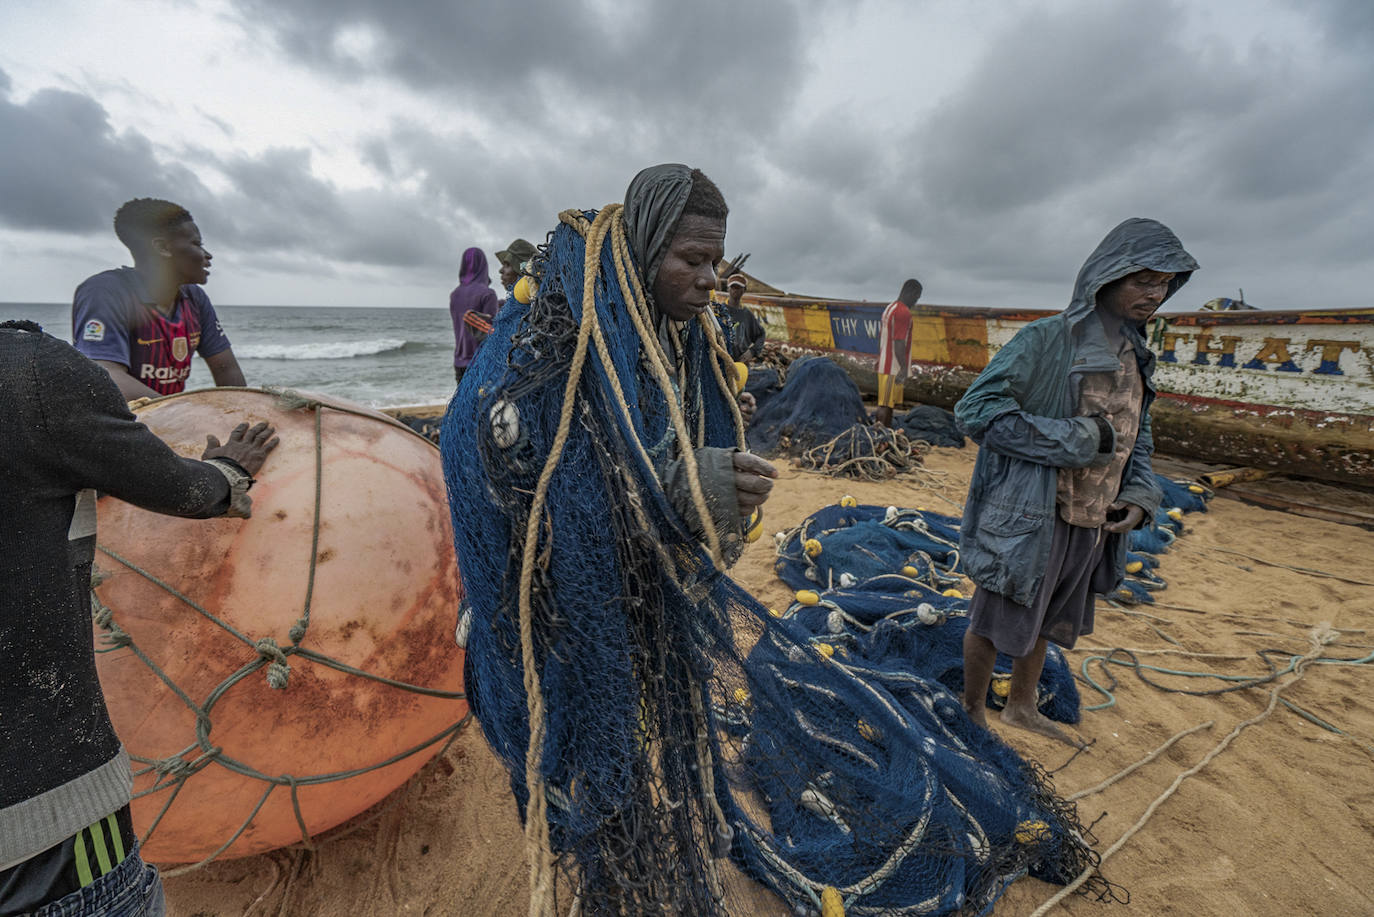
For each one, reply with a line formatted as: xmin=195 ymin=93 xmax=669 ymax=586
xmin=717 ymin=293 xmax=1374 ymax=487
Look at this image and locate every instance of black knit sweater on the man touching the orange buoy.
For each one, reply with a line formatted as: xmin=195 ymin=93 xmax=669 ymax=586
xmin=0 ymin=327 xmax=229 ymax=835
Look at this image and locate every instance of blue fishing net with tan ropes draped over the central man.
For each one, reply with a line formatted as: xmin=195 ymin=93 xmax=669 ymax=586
xmin=441 ymin=208 xmax=1094 ymax=914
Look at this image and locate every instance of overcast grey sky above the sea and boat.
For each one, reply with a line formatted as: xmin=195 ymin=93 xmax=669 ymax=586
xmin=0 ymin=0 xmax=1374 ymax=308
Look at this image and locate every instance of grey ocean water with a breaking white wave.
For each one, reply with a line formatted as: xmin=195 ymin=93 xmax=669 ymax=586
xmin=0 ymin=302 xmax=453 ymax=407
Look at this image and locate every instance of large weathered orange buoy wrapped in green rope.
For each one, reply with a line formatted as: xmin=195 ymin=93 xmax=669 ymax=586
xmin=95 ymin=389 xmax=467 ymax=863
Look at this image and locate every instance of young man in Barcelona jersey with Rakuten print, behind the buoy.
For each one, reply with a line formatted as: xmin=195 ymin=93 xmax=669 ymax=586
xmin=71 ymin=198 xmax=246 ymax=401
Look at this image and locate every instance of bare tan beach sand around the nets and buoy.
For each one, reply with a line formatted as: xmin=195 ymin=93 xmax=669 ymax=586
xmin=166 ymin=447 xmax=1374 ymax=917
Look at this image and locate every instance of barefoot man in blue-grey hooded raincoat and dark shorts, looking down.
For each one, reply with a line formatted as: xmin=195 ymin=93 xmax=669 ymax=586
xmin=955 ymin=219 xmax=1198 ymax=744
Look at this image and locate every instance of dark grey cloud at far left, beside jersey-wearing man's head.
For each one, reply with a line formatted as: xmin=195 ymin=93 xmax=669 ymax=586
xmin=0 ymin=71 xmax=205 ymax=234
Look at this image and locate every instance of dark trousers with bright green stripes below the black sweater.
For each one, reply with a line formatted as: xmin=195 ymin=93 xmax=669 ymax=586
xmin=0 ymin=807 xmax=165 ymax=917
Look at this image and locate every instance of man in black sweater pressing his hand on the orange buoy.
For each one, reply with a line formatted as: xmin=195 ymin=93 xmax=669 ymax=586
xmin=0 ymin=322 xmax=278 ymax=917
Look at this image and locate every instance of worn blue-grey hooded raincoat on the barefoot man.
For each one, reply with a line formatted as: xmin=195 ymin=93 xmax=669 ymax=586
xmin=955 ymin=219 xmax=1198 ymax=605
